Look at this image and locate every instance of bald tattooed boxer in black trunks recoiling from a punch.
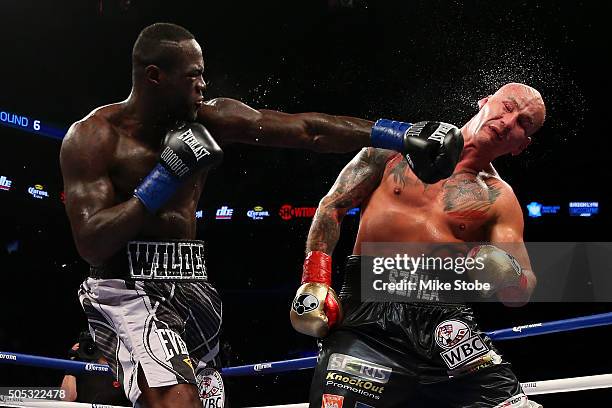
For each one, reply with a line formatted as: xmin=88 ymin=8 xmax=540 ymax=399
xmin=291 ymin=83 xmax=545 ymax=408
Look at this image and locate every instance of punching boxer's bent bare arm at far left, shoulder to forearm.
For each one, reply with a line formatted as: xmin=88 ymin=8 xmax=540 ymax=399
xmin=60 ymin=117 xmax=148 ymax=265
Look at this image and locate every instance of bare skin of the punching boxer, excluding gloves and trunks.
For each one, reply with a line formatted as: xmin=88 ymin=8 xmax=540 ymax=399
xmin=60 ymin=23 xmax=372 ymax=407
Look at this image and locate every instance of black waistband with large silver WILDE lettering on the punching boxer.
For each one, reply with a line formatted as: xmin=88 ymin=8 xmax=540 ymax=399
xmin=90 ymin=240 xmax=208 ymax=282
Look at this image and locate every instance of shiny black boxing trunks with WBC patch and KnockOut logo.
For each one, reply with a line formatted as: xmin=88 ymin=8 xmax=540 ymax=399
xmin=310 ymin=256 xmax=529 ymax=408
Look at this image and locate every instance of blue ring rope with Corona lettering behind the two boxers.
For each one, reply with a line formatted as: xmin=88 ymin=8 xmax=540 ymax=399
xmin=0 ymin=312 xmax=612 ymax=377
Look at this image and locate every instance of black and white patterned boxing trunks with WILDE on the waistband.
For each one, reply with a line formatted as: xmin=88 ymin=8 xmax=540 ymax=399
xmin=79 ymin=241 xmax=222 ymax=403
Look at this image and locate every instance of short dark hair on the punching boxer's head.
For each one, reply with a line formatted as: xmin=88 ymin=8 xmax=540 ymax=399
xmin=132 ymin=23 xmax=195 ymax=69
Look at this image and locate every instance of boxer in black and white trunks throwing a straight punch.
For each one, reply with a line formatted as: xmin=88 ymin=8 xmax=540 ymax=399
xmin=60 ymin=23 xmax=463 ymax=408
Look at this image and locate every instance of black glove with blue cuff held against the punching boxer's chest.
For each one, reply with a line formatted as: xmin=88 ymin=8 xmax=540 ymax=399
xmin=134 ymin=123 xmax=223 ymax=213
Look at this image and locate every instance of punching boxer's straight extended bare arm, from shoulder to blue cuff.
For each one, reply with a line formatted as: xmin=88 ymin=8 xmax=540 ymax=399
xmin=198 ymin=98 xmax=374 ymax=153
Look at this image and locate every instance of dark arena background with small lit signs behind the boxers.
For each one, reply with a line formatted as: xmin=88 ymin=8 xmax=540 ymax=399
xmin=0 ymin=0 xmax=612 ymax=408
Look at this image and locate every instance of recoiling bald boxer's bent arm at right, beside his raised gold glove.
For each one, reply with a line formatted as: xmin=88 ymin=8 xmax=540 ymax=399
xmin=488 ymin=186 xmax=537 ymax=306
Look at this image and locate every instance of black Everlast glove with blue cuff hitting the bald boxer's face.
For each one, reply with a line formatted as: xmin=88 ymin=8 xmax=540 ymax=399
xmin=370 ymin=119 xmax=463 ymax=184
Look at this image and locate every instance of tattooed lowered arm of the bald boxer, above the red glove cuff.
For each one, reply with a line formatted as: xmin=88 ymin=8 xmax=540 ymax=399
xmin=306 ymin=147 xmax=396 ymax=255
